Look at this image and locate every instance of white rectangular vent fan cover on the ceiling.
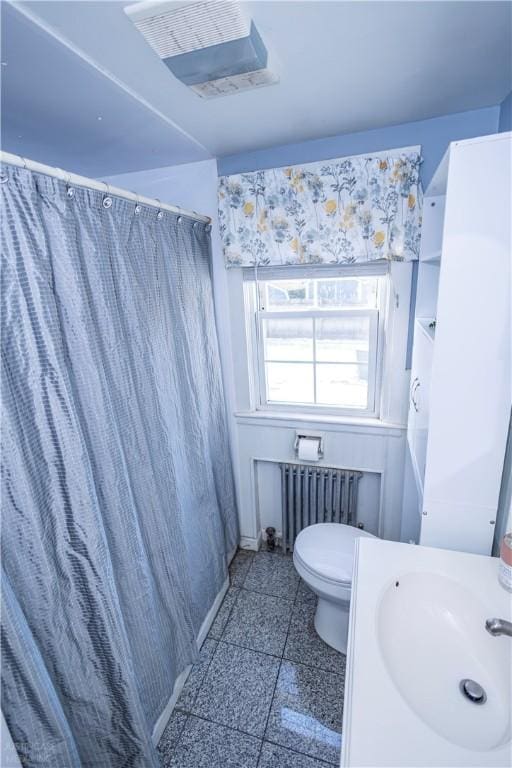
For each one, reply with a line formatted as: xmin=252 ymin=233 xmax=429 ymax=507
xmin=126 ymin=2 xmax=278 ymax=99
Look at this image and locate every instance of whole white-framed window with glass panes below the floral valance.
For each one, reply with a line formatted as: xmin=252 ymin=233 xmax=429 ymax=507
xmin=247 ymin=274 xmax=383 ymax=415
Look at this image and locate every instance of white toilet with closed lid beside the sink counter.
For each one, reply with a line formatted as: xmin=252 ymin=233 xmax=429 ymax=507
xmin=293 ymin=523 xmax=374 ymax=653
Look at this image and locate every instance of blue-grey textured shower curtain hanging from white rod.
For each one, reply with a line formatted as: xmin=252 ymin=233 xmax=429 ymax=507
xmin=0 ymin=166 xmax=238 ymax=768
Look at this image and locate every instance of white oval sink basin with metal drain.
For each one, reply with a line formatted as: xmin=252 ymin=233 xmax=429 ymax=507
xmin=376 ymin=571 xmax=512 ymax=752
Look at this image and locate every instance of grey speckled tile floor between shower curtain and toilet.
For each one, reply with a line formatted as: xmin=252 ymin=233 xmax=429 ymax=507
xmin=158 ymin=550 xmax=345 ymax=768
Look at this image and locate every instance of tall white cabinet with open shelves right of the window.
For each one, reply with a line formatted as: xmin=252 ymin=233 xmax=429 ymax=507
xmin=408 ymin=133 xmax=512 ymax=554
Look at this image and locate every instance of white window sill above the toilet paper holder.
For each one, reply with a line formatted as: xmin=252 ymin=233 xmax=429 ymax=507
xmin=234 ymin=410 xmax=407 ymax=435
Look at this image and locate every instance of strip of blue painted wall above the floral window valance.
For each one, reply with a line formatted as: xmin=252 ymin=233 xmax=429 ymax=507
xmin=217 ymin=105 xmax=500 ymax=187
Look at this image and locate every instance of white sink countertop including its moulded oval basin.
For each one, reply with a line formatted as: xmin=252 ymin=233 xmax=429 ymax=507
xmin=341 ymin=538 xmax=512 ymax=768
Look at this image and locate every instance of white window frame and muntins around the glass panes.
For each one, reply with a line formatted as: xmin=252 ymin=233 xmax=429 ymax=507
xmin=244 ymin=267 xmax=388 ymax=418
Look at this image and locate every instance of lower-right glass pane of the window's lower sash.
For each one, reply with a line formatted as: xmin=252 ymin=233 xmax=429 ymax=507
xmin=316 ymin=363 xmax=368 ymax=408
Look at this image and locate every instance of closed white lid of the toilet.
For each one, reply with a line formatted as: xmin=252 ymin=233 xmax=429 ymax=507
xmin=293 ymin=523 xmax=375 ymax=584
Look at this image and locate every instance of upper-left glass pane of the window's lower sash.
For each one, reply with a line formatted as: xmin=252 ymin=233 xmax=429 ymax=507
xmin=262 ymin=318 xmax=313 ymax=362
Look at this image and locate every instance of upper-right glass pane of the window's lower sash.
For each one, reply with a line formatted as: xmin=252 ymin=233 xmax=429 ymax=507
xmin=316 ymin=317 xmax=370 ymax=364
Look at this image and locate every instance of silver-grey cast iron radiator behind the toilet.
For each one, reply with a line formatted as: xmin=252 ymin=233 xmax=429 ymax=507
xmin=279 ymin=464 xmax=363 ymax=552
